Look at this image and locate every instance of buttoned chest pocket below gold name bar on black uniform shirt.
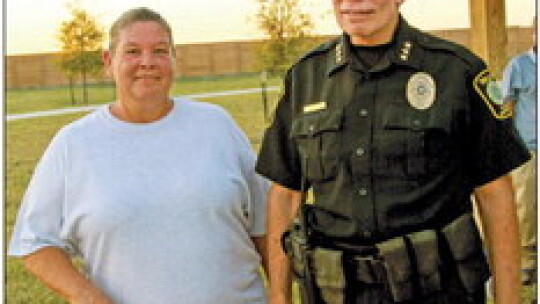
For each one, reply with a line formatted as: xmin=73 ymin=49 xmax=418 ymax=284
xmin=291 ymin=109 xmax=343 ymax=181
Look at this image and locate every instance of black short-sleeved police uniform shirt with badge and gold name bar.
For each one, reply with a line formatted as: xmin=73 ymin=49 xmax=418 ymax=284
xmin=257 ymin=17 xmax=529 ymax=242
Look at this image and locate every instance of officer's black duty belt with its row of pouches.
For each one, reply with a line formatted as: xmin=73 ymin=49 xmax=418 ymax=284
xmin=309 ymin=214 xmax=489 ymax=303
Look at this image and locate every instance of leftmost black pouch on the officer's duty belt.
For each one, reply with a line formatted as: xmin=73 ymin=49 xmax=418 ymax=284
xmin=312 ymin=247 xmax=346 ymax=304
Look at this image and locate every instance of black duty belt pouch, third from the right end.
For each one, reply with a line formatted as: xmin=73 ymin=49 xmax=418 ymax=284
xmin=376 ymin=237 xmax=413 ymax=302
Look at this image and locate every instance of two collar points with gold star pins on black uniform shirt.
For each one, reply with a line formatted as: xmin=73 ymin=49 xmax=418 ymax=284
xmin=328 ymin=16 xmax=423 ymax=75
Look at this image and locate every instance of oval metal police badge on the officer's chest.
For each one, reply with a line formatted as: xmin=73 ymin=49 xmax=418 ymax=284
xmin=407 ymin=72 xmax=436 ymax=110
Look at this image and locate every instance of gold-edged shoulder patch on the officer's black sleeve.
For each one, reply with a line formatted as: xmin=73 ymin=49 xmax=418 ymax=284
xmin=473 ymin=69 xmax=512 ymax=120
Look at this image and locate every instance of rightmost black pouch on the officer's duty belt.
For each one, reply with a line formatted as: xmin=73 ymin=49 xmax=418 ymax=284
xmin=443 ymin=213 xmax=489 ymax=293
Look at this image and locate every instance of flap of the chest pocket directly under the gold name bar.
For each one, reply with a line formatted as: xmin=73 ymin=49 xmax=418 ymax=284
xmin=291 ymin=109 xmax=343 ymax=138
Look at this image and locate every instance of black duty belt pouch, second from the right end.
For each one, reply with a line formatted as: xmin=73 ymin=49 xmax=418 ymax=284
xmin=407 ymin=230 xmax=441 ymax=295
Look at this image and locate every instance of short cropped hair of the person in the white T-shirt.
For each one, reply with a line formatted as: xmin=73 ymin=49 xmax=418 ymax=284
xmin=109 ymin=7 xmax=174 ymax=55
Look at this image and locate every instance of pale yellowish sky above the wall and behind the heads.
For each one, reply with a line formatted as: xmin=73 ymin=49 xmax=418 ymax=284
xmin=4 ymin=0 xmax=536 ymax=55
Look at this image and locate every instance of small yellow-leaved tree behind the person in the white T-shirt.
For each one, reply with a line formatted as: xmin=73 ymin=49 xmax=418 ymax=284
xmin=58 ymin=7 xmax=104 ymax=104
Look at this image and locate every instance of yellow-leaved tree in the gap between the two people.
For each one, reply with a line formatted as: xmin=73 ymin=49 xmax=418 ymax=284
xmin=256 ymin=0 xmax=313 ymax=77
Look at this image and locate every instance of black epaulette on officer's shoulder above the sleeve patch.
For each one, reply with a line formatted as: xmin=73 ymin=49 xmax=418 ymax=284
xmin=416 ymin=32 xmax=483 ymax=68
